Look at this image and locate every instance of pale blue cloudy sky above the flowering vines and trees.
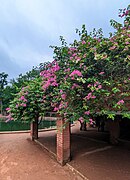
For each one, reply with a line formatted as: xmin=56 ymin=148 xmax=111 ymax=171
xmin=0 ymin=0 xmax=129 ymax=79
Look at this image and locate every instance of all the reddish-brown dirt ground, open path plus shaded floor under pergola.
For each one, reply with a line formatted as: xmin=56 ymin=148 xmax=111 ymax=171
xmin=0 ymin=124 xmax=130 ymax=180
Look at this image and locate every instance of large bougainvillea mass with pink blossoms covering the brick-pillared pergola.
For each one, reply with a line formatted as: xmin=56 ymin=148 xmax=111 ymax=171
xmin=8 ymin=4 xmax=130 ymax=127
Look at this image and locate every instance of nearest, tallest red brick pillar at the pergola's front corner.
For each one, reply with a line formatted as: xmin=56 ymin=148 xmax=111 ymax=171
xmin=57 ymin=118 xmax=70 ymax=166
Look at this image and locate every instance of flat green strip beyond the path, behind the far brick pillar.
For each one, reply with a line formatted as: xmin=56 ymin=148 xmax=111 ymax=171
xmin=0 ymin=121 xmax=56 ymax=131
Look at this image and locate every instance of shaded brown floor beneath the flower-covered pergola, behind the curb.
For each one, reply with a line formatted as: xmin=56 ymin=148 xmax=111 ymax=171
xmin=39 ymin=121 xmax=130 ymax=180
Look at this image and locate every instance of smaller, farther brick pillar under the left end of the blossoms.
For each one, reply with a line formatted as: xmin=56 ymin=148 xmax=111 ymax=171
xmin=30 ymin=121 xmax=38 ymax=141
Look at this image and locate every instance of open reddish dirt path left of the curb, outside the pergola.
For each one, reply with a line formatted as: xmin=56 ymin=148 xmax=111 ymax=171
xmin=0 ymin=133 xmax=81 ymax=180
